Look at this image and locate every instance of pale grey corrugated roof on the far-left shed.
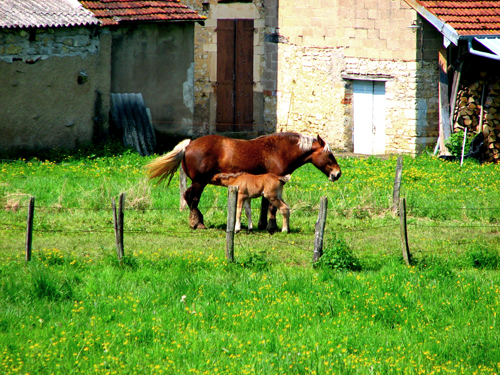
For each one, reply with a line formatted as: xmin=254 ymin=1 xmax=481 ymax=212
xmin=0 ymin=0 xmax=99 ymax=28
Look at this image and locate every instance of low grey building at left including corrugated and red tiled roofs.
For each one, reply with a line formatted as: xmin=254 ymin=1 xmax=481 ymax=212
xmin=0 ymin=0 xmax=204 ymax=151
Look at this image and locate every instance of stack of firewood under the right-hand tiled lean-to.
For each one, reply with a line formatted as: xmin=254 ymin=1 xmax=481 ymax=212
xmin=453 ymin=77 xmax=500 ymax=163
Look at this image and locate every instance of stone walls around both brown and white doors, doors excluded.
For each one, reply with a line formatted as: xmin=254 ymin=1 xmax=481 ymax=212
xmin=188 ymin=0 xmax=442 ymax=153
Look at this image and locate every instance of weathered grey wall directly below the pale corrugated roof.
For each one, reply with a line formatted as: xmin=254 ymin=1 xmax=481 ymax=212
xmin=0 ymin=27 xmax=111 ymax=150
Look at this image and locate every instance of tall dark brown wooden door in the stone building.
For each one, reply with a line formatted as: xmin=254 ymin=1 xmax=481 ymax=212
xmin=216 ymin=19 xmax=254 ymax=132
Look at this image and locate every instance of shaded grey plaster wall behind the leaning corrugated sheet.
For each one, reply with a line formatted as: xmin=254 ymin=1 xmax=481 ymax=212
xmin=111 ymin=22 xmax=194 ymax=137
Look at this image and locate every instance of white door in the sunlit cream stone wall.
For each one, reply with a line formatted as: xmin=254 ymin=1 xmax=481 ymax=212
xmin=353 ymin=81 xmax=385 ymax=155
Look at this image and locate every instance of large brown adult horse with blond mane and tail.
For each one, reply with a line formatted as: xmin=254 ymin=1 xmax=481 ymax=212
xmin=146 ymin=133 xmax=341 ymax=232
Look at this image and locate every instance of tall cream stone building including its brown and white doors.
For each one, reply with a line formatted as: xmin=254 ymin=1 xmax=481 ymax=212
xmin=188 ymin=0 xmax=500 ymax=154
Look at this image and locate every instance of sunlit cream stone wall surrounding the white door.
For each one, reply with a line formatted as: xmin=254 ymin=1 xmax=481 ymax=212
xmin=264 ymin=0 xmax=442 ymax=153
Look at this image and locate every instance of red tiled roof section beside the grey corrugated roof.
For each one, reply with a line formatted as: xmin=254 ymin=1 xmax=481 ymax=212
xmin=80 ymin=0 xmax=206 ymax=25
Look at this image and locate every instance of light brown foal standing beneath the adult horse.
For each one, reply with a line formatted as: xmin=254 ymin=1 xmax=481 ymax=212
xmin=210 ymin=172 xmax=290 ymax=233
